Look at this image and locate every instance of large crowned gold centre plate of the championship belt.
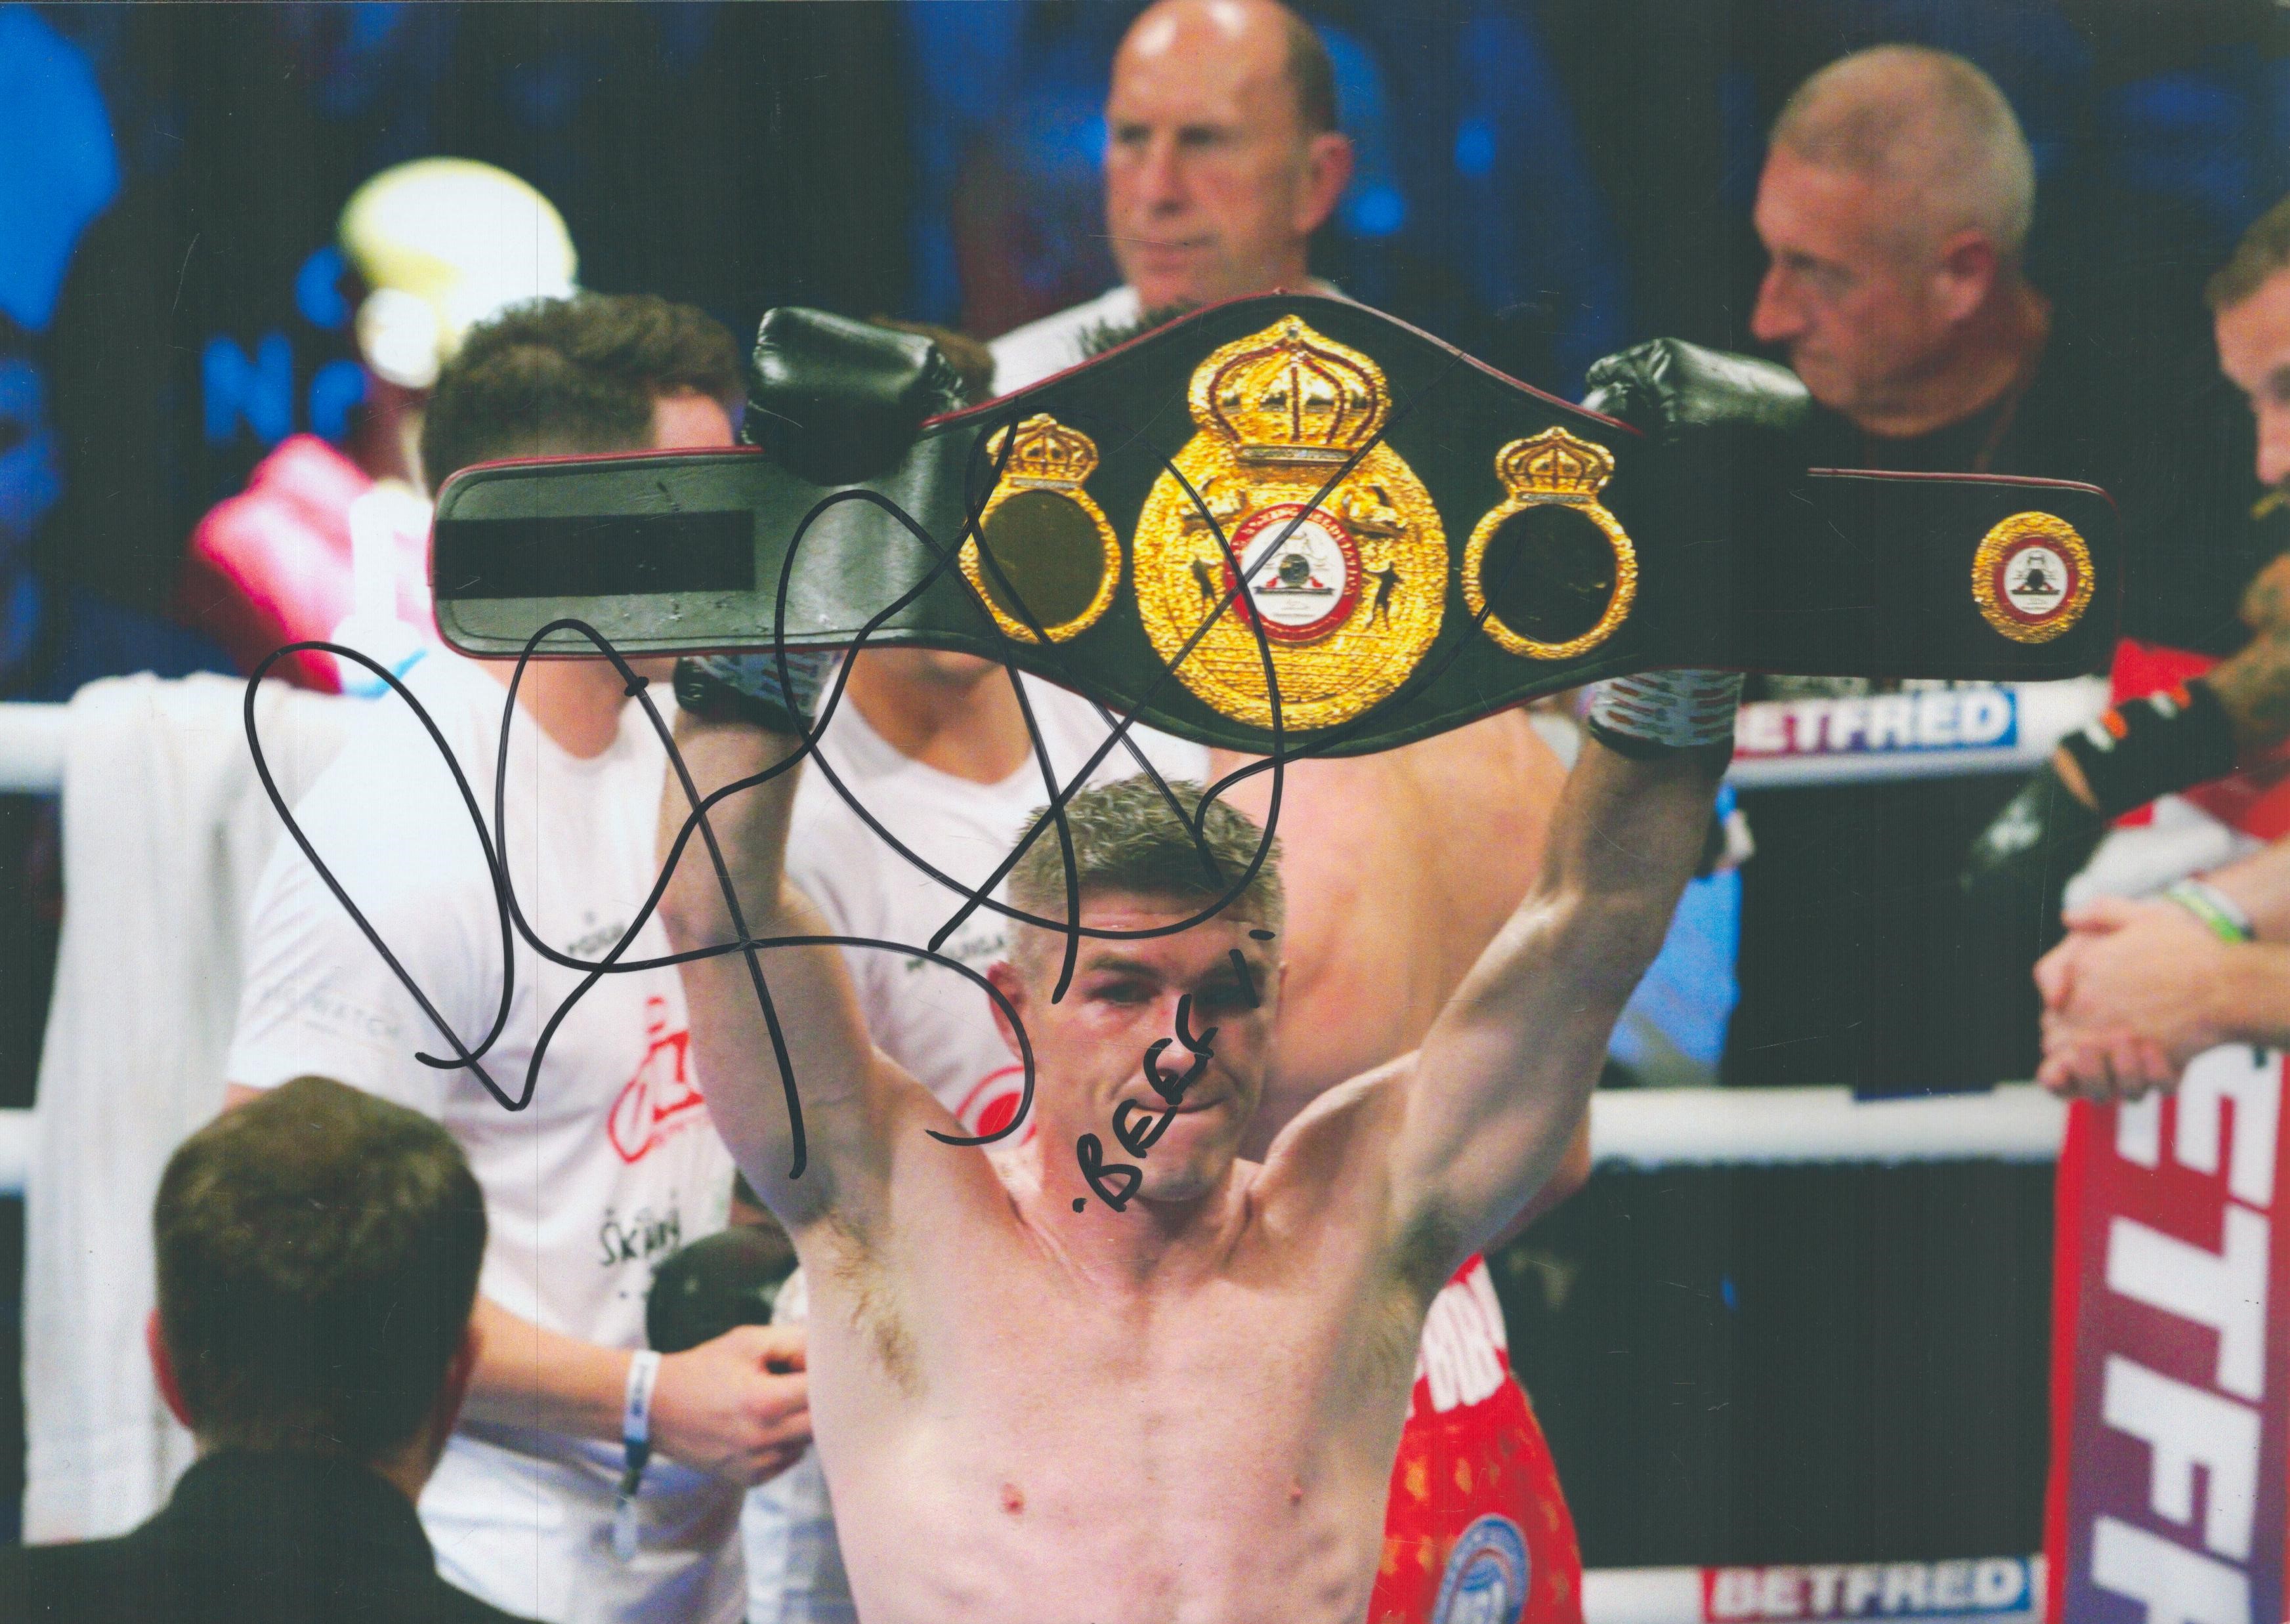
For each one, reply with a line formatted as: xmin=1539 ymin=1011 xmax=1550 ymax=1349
xmin=1132 ymin=316 xmax=1447 ymax=728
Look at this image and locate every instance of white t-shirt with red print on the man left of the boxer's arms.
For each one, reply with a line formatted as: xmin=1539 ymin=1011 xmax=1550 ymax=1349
xmin=229 ymin=650 xmax=744 ymax=1624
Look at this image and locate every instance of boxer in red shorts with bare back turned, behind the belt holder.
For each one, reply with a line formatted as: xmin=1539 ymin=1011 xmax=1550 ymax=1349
xmin=1214 ymin=728 xmax=1589 ymax=1624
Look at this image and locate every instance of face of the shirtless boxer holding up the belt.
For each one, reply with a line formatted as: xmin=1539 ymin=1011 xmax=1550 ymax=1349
xmin=992 ymin=893 xmax=1280 ymax=1200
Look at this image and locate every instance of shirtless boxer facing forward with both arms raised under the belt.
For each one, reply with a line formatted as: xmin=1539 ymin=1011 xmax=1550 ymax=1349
xmin=662 ymin=600 xmax=1738 ymax=1624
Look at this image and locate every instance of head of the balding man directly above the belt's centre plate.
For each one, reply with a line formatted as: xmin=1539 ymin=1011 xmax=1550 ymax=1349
xmin=1106 ymin=0 xmax=1351 ymax=309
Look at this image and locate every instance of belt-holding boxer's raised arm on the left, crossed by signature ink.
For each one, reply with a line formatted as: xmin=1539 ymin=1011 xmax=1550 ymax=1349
xmin=660 ymin=655 xmax=895 ymax=1230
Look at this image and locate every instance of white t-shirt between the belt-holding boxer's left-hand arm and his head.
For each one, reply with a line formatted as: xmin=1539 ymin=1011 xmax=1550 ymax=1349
xmin=788 ymin=676 xmax=1209 ymax=1143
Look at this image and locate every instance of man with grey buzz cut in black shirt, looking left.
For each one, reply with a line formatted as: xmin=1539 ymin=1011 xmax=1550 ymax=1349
xmin=1727 ymin=46 xmax=2290 ymax=1093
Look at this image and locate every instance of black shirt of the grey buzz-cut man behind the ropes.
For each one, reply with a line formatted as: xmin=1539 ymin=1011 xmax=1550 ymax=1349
xmin=1724 ymin=325 xmax=2281 ymax=1093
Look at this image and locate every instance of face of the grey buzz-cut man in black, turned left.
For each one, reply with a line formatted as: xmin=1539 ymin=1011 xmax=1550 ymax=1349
xmin=1750 ymin=146 xmax=1949 ymax=417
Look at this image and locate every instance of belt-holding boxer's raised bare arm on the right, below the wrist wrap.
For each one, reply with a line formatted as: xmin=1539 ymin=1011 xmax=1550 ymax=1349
xmin=1392 ymin=742 xmax=1718 ymax=1266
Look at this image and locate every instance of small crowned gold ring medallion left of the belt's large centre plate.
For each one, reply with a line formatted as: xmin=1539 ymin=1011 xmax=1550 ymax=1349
xmin=962 ymin=412 xmax=1122 ymax=644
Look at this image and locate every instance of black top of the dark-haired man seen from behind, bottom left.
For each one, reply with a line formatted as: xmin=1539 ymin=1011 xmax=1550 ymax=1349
xmin=0 ymin=1452 xmax=531 ymax=1624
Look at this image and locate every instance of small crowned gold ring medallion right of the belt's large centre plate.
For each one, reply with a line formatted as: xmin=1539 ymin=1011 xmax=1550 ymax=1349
xmin=1463 ymin=428 xmax=1638 ymax=659
